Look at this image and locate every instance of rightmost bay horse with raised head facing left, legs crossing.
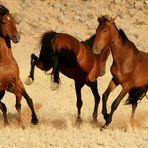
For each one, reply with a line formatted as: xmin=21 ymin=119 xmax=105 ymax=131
xmin=93 ymin=18 xmax=148 ymax=127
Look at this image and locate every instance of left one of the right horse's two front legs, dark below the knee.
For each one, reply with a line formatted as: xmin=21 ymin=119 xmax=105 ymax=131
xmin=102 ymin=78 xmax=118 ymax=120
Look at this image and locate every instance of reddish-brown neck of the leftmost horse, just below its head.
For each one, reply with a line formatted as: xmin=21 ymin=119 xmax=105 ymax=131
xmin=0 ymin=37 xmax=12 ymax=61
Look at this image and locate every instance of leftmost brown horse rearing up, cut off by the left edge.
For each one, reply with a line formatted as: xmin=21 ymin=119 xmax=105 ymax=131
xmin=0 ymin=5 xmax=38 ymax=125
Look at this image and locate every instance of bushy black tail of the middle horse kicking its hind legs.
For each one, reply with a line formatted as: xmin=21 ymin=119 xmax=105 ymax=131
xmin=39 ymin=31 xmax=56 ymax=69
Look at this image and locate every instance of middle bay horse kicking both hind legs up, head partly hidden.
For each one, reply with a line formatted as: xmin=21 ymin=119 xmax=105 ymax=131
xmin=24 ymin=31 xmax=110 ymax=120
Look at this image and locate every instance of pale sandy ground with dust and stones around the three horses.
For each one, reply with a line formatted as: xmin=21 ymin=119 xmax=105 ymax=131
xmin=0 ymin=0 xmax=148 ymax=148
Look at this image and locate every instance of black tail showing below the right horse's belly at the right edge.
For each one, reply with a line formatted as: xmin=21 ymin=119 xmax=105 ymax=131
xmin=125 ymin=85 xmax=148 ymax=105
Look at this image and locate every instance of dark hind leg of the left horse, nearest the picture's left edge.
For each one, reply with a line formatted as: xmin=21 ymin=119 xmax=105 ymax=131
xmin=0 ymin=91 xmax=9 ymax=126
